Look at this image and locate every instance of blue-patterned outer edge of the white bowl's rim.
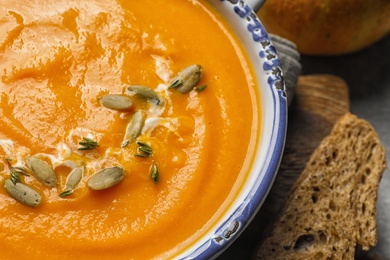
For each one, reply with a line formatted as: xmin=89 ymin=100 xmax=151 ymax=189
xmin=180 ymin=0 xmax=287 ymax=259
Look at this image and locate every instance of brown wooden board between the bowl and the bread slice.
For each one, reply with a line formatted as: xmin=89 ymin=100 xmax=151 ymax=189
xmin=218 ymin=75 xmax=349 ymax=260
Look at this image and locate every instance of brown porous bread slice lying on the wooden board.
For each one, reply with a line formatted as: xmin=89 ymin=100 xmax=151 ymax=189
xmin=256 ymin=113 xmax=386 ymax=259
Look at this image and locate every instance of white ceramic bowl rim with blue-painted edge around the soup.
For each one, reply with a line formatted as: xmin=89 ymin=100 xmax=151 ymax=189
xmin=179 ymin=0 xmax=287 ymax=259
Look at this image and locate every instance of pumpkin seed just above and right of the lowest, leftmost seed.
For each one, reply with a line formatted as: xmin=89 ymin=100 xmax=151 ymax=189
xmin=26 ymin=156 xmax=57 ymax=188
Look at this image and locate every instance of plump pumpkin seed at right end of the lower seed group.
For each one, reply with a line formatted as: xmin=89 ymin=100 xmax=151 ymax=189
xmin=88 ymin=166 xmax=125 ymax=190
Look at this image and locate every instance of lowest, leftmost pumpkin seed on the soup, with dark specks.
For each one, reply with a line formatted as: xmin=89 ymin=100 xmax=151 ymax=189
xmin=4 ymin=179 xmax=42 ymax=207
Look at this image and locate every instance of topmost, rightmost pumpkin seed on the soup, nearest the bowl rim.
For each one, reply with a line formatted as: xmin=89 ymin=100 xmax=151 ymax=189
xmin=170 ymin=64 xmax=203 ymax=94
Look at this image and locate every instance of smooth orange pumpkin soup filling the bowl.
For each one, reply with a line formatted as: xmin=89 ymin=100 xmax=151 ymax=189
xmin=0 ymin=0 xmax=260 ymax=259
